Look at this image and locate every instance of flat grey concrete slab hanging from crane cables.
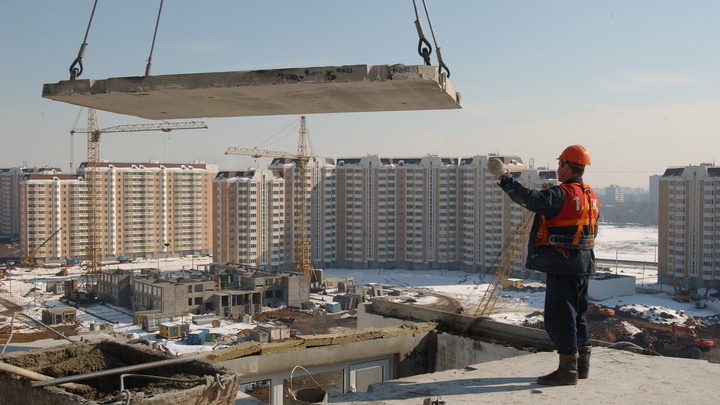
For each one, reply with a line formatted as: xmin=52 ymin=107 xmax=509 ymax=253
xmin=42 ymin=65 xmax=462 ymax=120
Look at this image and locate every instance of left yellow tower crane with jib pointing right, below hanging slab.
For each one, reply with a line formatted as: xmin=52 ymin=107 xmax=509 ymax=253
xmin=70 ymin=108 xmax=207 ymax=295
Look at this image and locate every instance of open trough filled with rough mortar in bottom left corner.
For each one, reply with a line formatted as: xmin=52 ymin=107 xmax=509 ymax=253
xmin=0 ymin=340 xmax=240 ymax=405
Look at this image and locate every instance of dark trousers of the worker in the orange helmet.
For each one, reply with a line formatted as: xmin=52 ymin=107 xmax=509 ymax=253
xmin=545 ymin=274 xmax=591 ymax=354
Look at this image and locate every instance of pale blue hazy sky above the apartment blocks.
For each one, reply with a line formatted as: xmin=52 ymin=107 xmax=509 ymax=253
xmin=0 ymin=0 xmax=720 ymax=187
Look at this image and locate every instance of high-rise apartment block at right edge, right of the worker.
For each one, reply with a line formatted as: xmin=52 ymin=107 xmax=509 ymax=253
xmin=658 ymin=164 xmax=720 ymax=288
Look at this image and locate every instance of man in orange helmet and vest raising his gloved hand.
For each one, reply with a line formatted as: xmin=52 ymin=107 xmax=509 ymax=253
xmin=487 ymin=145 xmax=599 ymax=385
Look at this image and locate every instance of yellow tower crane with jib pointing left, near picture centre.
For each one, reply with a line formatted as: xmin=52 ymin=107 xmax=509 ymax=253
xmin=225 ymin=116 xmax=315 ymax=282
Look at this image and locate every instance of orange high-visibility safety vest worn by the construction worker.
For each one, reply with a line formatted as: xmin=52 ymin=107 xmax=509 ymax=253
xmin=535 ymin=183 xmax=599 ymax=250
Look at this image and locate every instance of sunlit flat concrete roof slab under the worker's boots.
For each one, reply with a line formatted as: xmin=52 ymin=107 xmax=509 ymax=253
xmin=328 ymin=347 xmax=720 ymax=405
